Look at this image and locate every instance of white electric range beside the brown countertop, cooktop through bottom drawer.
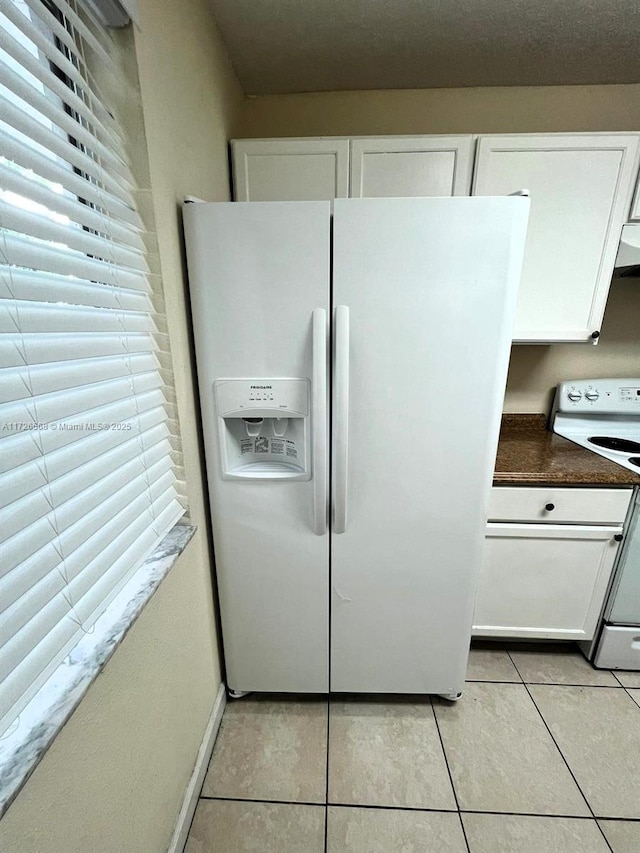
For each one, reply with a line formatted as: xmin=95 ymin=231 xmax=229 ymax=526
xmin=551 ymin=379 xmax=640 ymax=671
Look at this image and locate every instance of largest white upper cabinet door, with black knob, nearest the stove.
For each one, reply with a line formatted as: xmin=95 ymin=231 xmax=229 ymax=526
xmin=473 ymin=133 xmax=640 ymax=342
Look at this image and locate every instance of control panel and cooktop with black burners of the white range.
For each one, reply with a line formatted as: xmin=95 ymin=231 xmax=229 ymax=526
xmin=551 ymin=379 xmax=640 ymax=473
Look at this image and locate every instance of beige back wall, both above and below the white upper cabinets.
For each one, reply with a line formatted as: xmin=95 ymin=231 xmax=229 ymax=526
xmin=240 ymin=84 xmax=640 ymax=412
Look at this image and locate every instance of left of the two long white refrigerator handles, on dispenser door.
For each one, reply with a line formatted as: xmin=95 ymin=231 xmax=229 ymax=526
xmin=311 ymin=308 xmax=328 ymax=536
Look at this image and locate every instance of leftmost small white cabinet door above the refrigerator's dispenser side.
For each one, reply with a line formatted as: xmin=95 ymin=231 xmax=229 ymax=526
xmin=231 ymin=139 xmax=349 ymax=201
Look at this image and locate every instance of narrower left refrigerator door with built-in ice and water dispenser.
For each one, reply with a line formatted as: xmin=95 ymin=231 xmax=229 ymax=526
xmin=184 ymin=202 xmax=330 ymax=693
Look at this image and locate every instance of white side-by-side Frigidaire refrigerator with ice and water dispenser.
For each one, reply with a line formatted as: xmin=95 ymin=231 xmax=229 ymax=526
xmin=184 ymin=197 xmax=529 ymax=698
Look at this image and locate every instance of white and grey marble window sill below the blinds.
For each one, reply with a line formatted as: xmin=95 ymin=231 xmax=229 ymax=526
xmin=0 ymin=523 xmax=196 ymax=818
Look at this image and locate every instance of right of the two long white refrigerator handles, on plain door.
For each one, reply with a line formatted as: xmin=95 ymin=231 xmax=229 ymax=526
xmin=333 ymin=305 xmax=349 ymax=533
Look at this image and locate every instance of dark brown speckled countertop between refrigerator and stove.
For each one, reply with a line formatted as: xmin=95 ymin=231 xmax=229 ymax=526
xmin=493 ymin=414 xmax=640 ymax=486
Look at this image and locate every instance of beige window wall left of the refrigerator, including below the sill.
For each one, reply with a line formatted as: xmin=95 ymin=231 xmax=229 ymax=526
xmin=0 ymin=0 xmax=242 ymax=853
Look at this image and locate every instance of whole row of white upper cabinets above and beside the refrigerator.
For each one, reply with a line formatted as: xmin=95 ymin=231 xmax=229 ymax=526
xmin=231 ymin=133 xmax=640 ymax=343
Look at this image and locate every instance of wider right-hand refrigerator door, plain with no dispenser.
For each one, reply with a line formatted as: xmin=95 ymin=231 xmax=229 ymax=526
xmin=331 ymin=197 xmax=529 ymax=694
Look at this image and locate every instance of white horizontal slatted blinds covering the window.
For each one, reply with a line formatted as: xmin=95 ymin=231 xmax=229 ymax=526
xmin=0 ymin=0 xmax=185 ymax=731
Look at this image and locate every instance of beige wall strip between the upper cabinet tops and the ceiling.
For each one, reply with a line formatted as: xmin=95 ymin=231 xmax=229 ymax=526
xmin=240 ymin=84 xmax=640 ymax=137
